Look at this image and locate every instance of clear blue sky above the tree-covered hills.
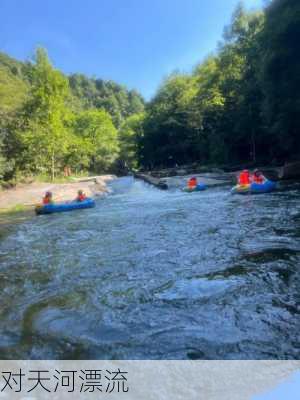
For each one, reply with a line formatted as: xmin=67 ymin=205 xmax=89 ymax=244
xmin=0 ymin=0 xmax=263 ymax=98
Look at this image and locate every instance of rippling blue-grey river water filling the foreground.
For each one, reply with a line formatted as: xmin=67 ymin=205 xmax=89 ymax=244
xmin=0 ymin=178 xmax=300 ymax=359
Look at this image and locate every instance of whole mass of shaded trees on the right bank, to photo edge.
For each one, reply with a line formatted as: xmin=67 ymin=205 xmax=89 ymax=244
xmin=139 ymin=0 xmax=300 ymax=168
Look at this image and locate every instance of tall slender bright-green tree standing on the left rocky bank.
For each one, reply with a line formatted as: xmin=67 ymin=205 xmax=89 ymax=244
xmin=19 ymin=48 xmax=71 ymax=179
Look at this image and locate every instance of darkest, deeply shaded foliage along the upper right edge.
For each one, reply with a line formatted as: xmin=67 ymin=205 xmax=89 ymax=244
xmin=261 ymin=0 xmax=300 ymax=159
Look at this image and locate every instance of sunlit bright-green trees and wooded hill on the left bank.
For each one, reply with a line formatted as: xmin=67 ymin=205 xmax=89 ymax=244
xmin=0 ymin=45 xmax=144 ymax=180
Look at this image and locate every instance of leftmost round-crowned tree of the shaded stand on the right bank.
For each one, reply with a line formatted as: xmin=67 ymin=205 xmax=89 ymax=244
xmin=140 ymin=73 xmax=196 ymax=167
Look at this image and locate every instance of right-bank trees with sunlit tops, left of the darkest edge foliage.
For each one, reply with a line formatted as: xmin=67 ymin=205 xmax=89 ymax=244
xmin=140 ymin=5 xmax=268 ymax=167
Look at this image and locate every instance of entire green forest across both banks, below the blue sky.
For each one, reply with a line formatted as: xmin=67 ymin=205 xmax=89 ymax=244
xmin=0 ymin=0 xmax=300 ymax=180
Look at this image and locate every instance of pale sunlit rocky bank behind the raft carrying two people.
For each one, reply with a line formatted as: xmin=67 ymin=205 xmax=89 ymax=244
xmin=0 ymin=175 xmax=116 ymax=213
